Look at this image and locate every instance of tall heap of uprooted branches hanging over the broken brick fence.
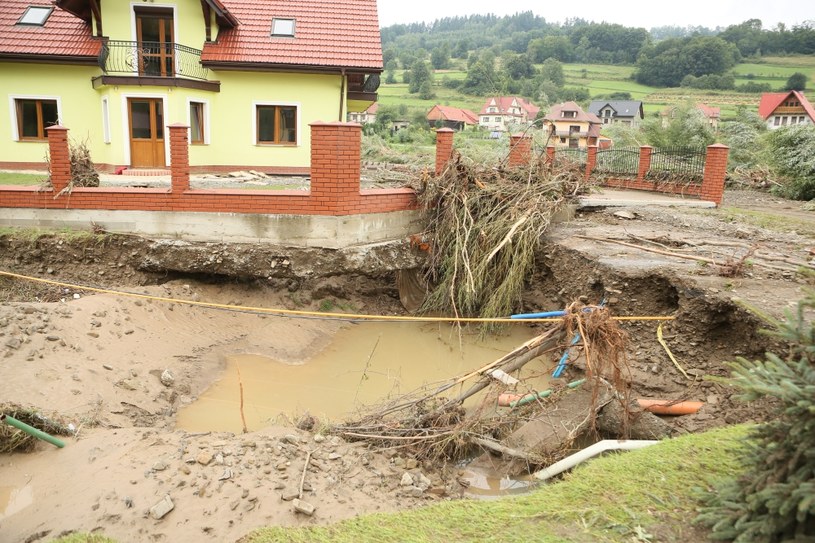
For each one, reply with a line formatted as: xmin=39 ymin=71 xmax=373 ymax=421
xmin=420 ymin=155 xmax=588 ymax=332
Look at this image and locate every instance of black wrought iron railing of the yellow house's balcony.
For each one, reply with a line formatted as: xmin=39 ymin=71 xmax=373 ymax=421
xmin=99 ymin=40 xmax=209 ymax=81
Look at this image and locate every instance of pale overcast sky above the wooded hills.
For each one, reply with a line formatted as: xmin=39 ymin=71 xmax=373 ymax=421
xmin=377 ymin=0 xmax=815 ymax=29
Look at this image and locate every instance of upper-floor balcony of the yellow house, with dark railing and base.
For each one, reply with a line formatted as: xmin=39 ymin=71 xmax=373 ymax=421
xmin=93 ymin=40 xmax=221 ymax=92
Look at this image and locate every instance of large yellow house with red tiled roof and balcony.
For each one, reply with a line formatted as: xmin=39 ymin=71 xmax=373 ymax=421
xmin=0 ymin=0 xmax=382 ymax=173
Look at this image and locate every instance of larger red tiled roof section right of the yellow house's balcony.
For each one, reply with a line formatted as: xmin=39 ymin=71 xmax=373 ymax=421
xmin=201 ymin=0 xmax=382 ymax=71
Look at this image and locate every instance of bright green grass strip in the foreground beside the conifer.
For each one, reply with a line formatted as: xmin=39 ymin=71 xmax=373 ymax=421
xmin=244 ymin=426 xmax=747 ymax=543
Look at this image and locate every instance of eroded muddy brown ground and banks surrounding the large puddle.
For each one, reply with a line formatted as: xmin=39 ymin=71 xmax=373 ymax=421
xmin=0 ymin=192 xmax=815 ymax=541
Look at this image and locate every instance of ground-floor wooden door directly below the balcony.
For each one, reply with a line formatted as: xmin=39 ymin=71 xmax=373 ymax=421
xmin=127 ymin=98 xmax=166 ymax=168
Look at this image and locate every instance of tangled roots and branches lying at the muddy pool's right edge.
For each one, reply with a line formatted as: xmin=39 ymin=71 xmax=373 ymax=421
xmin=332 ymin=304 xmax=629 ymax=465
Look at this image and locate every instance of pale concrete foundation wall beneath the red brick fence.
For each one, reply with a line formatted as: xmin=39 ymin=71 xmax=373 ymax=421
xmin=0 ymin=208 xmax=423 ymax=249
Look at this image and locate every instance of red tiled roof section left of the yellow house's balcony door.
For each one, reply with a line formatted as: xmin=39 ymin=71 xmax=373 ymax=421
xmin=0 ymin=0 xmax=102 ymax=59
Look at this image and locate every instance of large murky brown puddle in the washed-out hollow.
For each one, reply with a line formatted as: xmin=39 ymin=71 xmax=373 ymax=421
xmin=177 ymin=322 xmax=551 ymax=433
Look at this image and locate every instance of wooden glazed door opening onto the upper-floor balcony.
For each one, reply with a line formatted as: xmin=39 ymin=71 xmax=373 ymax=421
xmin=135 ymin=7 xmax=175 ymax=77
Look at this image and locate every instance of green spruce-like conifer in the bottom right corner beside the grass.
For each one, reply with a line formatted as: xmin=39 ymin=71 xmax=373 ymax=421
xmin=698 ymin=278 xmax=815 ymax=543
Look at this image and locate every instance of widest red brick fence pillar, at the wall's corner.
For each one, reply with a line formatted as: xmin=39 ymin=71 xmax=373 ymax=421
xmin=311 ymin=122 xmax=362 ymax=215
